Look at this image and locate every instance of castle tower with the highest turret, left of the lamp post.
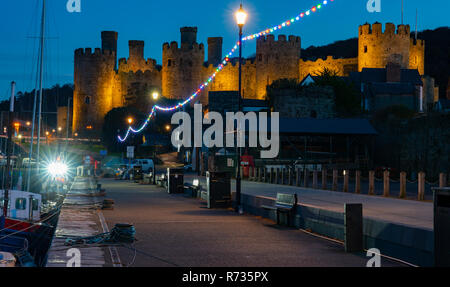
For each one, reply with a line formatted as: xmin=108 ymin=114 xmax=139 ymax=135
xmin=162 ymin=27 xmax=206 ymax=103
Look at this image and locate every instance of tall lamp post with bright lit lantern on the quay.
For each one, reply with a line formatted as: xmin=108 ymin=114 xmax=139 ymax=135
xmin=236 ymin=3 xmax=247 ymax=212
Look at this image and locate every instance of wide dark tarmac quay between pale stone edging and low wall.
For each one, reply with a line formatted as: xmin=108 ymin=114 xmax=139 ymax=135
xmin=100 ymin=179 xmax=404 ymax=267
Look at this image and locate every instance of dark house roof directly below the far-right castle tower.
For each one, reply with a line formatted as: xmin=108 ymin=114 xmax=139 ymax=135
xmin=350 ymin=68 xmax=423 ymax=86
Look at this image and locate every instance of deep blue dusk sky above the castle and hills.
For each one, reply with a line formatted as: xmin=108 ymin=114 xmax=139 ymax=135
xmin=0 ymin=0 xmax=450 ymax=99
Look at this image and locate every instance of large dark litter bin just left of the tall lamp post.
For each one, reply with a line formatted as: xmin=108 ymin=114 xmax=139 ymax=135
xmin=206 ymin=171 xmax=231 ymax=208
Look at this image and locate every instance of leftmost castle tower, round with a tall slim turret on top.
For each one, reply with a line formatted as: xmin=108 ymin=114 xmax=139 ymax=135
xmin=72 ymin=32 xmax=117 ymax=135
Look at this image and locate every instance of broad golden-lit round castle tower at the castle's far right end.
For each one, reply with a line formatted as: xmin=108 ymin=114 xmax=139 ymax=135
xmin=358 ymin=23 xmax=410 ymax=71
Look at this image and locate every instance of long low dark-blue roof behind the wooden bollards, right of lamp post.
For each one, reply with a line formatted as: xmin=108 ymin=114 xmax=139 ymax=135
xmin=246 ymin=118 xmax=377 ymax=135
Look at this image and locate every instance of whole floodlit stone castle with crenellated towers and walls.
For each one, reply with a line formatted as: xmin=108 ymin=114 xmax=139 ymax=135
xmin=72 ymin=23 xmax=425 ymax=134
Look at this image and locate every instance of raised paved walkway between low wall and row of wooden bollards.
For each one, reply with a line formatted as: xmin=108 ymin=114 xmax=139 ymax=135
xmin=184 ymin=175 xmax=433 ymax=230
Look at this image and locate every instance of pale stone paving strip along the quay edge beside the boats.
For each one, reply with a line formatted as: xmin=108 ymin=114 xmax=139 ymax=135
xmin=46 ymin=177 xmax=111 ymax=267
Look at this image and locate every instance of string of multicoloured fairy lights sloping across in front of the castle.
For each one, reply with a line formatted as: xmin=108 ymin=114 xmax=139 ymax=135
xmin=117 ymin=0 xmax=334 ymax=142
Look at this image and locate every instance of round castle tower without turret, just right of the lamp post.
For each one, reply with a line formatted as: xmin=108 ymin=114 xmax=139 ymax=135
xmin=256 ymin=35 xmax=301 ymax=99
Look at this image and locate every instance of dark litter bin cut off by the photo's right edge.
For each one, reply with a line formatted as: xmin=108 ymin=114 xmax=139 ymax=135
xmin=433 ymin=187 xmax=450 ymax=267
